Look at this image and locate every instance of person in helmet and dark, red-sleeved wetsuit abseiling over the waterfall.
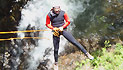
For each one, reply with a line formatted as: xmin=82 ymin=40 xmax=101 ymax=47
xmin=46 ymin=6 xmax=94 ymax=69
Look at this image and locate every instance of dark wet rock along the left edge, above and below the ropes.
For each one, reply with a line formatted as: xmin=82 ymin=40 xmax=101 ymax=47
xmin=0 ymin=0 xmax=29 ymax=70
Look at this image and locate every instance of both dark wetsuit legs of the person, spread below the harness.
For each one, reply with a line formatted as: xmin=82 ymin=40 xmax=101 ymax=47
xmin=53 ymin=30 xmax=87 ymax=62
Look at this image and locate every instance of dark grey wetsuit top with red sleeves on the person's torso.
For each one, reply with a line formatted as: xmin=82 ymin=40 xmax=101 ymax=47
xmin=46 ymin=10 xmax=70 ymax=29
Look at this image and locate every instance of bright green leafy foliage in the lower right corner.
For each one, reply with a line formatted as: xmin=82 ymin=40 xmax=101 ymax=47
xmin=75 ymin=41 xmax=123 ymax=70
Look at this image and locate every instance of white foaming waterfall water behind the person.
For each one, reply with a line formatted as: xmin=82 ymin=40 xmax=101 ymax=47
xmin=18 ymin=0 xmax=85 ymax=70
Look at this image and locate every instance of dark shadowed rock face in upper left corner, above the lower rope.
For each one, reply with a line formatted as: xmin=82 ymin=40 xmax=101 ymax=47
xmin=0 ymin=0 xmax=28 ymax=38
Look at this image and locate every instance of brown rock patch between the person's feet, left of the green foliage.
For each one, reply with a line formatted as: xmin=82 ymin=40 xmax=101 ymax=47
xmin=58 ymin=51 xmax=86 ymax=70
